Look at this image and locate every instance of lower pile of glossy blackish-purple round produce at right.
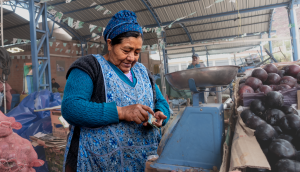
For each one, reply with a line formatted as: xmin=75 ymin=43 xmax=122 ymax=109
xmin=241 ymin=91 xmax=300 ymax=172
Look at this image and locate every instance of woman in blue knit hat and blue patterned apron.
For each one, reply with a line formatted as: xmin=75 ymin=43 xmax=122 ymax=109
xmin=62 ymin=10 xmax=170 ymax=172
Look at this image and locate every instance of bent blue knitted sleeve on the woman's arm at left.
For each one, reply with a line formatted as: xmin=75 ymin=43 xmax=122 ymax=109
xmin=61 ymin=68 xmax=119 ymax=128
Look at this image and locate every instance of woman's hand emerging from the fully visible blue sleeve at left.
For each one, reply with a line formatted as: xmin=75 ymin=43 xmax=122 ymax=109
xmin=117 ymin=104 xmax=154 ymax=124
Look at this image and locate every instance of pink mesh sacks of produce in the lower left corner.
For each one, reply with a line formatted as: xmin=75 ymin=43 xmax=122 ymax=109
xmin=0 ymin=112 xmax=44 ymax=172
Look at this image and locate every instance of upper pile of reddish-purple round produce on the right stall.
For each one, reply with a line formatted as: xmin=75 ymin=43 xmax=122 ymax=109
xmin=238 ymin=64 xmax=300 ymax=101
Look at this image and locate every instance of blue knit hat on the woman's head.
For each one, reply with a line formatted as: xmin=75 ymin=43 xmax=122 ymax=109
xmin=103 ymin=10 xmax=143 ymax=41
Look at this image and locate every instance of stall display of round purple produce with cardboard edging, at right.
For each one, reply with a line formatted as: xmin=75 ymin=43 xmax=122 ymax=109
xmin=230 ymin=62 xmax=300 ymax=172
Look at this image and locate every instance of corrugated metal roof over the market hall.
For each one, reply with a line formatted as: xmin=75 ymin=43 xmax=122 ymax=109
xmin=4 ymin=0 xmax=289 ymax=53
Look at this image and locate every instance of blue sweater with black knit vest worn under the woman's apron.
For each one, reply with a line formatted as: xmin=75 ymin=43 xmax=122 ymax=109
xmin=62 ymin=55 xmax=170 ymax=171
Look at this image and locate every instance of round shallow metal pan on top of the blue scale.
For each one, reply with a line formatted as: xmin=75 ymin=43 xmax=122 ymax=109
xmin=165 ymin=66 xmax=239 ymax=90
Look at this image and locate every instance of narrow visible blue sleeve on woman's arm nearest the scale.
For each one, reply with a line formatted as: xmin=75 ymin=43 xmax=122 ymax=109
xmin=154 ymin=84 xmax=170 ymax=126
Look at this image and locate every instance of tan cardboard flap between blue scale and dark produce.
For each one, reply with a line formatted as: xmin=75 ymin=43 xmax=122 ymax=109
xmin=230 ymin=106 xmax=271 ymax=171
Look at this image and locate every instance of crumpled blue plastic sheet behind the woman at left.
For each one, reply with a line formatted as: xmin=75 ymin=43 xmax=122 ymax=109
xmin=6 ymin=90 xmax=61 ymax=172
